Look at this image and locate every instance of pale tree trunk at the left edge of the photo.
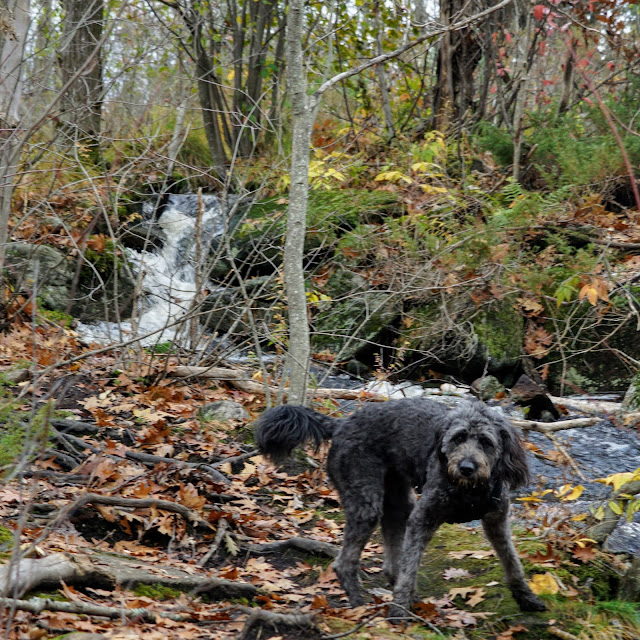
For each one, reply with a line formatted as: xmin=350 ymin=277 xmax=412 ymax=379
xmin=0 ymin=0 xmax=30 ymax=280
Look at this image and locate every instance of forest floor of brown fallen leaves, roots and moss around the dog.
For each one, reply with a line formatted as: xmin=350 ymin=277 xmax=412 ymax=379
xmin=0 ymin=324 xmax=640 ymax=640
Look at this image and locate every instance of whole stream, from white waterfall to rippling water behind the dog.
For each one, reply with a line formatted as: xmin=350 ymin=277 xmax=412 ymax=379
xmin=77 ymin=195 xmax=640 ymax=554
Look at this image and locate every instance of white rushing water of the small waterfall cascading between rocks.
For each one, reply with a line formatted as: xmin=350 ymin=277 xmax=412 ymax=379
xmin=76 ymin=196 xmax=224 ymax=346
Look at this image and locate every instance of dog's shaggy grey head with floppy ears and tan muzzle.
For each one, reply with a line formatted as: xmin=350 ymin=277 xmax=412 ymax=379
xmin=438 ymin=403 xmax=529 ymax=489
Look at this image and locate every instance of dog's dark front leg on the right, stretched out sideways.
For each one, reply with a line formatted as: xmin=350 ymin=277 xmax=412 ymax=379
xmin=482 ymin=501 xmax=547 ymax=611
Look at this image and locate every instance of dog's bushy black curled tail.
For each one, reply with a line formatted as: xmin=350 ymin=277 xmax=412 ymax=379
xmin=254 ymin=404 xmax=339 ymax=463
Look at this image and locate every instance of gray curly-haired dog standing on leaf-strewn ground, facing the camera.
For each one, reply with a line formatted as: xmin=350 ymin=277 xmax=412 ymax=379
xmin=256 ymin=398 xmax=545 ymax=617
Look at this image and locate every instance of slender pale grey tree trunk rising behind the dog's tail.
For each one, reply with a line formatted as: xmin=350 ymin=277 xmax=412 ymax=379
xmin=283 ymin=0 xmax=312 ymax=404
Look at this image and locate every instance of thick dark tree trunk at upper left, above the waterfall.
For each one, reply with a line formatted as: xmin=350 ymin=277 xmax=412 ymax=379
xmin=58 ymin=0 xmax=104 ymax=151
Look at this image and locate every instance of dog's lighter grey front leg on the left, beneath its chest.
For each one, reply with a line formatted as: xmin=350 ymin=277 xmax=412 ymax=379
xmin=389 ymin=491 xmax=442 ymax=619
